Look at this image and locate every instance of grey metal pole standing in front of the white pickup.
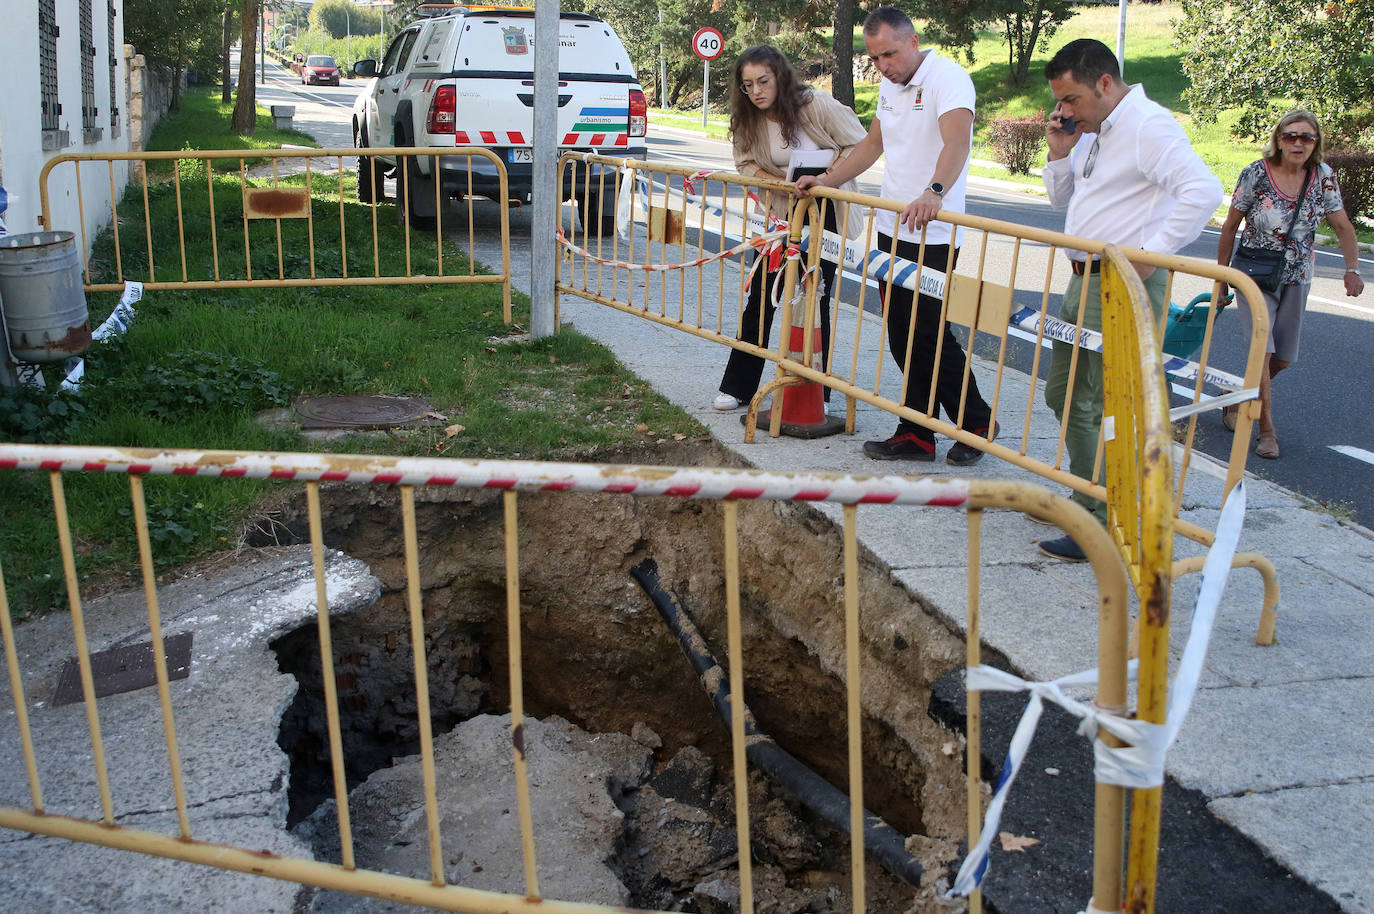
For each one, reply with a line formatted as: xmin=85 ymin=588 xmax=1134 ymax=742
xmin=529 ymin=0 xmax=563 ymax=339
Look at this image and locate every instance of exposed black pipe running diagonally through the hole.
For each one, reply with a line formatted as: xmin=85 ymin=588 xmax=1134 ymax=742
xmin=629 ymin=558 xmax=921 ymax=888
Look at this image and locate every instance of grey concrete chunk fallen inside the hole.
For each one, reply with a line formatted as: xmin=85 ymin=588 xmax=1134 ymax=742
xmin=295 ymin=715 xmax=650 ymax=914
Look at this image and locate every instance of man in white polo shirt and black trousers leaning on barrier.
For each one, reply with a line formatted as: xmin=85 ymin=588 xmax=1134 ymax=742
xmin=797 ymin=7 xmax=996 ymax=466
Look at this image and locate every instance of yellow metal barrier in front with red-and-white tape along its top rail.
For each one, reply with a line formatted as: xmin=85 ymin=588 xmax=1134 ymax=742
xmin=0 ymin=445 xmax=1128 ymax=914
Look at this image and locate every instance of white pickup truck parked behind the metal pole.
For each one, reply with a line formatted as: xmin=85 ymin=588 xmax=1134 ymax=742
xmin=343 ymin=7 xmax=649 ymax=231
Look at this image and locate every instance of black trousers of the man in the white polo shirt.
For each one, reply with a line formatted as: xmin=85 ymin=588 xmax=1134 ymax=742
xmin=878 ymin=232 xmax=992 ymax=441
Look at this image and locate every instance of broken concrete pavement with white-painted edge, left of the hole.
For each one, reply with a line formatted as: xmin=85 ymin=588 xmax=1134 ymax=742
xmin=0 ymin=547 xmax=379 ymax=913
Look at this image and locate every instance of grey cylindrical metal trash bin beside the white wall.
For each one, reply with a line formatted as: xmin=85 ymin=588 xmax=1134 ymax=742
xmin=0 ymin=232 xmax=91 ymax=361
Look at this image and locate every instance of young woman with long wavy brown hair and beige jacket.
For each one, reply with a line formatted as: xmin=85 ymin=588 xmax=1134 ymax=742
xmin=712 ymin=44 xmax=866 ymax=410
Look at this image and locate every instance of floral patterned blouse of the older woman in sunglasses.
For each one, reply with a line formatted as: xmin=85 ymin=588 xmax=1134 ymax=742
xmin=1231 ymin=159 xmax=1345 ymax=283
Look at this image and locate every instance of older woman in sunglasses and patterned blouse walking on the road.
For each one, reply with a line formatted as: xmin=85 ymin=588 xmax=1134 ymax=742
xmin=1216 ymin=111 xmax=1364 ymax=460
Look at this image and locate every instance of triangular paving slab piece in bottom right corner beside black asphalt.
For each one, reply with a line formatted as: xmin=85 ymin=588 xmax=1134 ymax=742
xmin=1208 ymin=783 xmax=1374 ymax=914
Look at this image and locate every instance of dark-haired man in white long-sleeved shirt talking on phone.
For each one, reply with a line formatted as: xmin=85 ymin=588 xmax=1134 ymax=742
xmin=1040 ymin=38 xmax=1221 ymax=562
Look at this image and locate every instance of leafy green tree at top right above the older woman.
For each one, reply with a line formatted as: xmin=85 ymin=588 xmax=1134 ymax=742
xmin=1173 ymin=0 xmax=1374 ymax=139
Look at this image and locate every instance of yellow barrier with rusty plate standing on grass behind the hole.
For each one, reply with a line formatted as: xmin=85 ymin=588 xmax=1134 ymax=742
xmin=38 ymin=147 xmax=511 ymax=322
